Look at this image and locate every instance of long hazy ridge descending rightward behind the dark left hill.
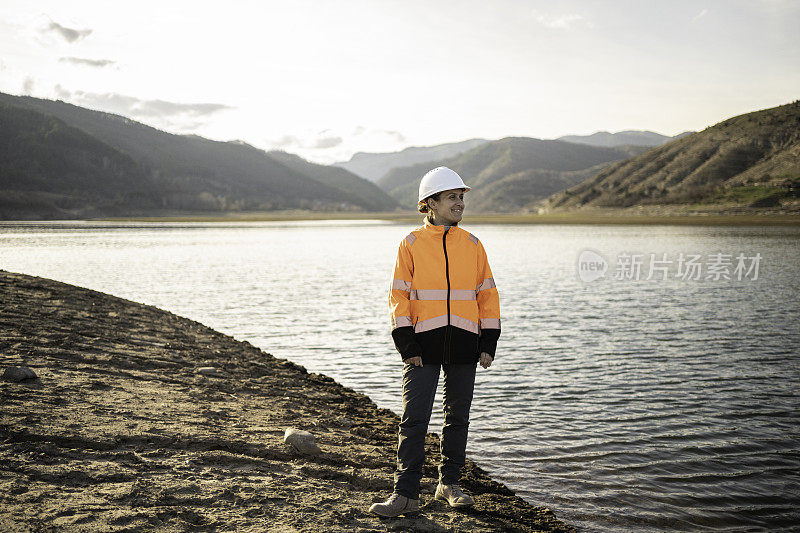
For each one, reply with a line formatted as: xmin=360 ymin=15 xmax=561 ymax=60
xmin=0 ymin=93 xmax=388 ymax=214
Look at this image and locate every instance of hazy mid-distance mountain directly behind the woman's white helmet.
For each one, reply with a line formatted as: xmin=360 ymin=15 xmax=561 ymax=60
xmin=377 ymin=137 xmax=644 ymax=212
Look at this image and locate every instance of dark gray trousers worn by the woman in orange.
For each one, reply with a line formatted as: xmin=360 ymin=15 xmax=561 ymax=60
xmin=394 ymin=364 xmax=477 ymax=500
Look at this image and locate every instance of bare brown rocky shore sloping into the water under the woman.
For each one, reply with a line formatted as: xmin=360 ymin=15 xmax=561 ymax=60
xmin=0 ymin=270 xmax=574 ymax=532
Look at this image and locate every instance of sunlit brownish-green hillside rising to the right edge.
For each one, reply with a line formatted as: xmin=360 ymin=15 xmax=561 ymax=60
xmin=546 ymin=100 xmax=800 ymax=209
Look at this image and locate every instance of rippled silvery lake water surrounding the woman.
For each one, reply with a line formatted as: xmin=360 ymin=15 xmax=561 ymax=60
xmin=0 ymin=220 xmax=800 ymax=531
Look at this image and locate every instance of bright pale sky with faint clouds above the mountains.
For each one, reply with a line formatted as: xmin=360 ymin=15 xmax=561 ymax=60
xmin=0 ymin=0 xmax=800 ymax=163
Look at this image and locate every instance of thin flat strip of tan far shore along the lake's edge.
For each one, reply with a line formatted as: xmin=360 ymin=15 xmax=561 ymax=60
xmin=90 ymin=209 xmax=800 ymax=226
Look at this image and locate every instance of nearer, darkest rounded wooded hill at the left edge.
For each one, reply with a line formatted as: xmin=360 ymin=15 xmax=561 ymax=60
xmin=0 ymin=104 xmax=160 ymax=219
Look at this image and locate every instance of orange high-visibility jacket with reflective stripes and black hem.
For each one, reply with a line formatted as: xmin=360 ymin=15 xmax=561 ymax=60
xmin=389 ymin=217 xmax=500 ymax=363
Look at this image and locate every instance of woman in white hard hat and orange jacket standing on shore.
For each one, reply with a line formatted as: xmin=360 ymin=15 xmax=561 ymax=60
xmin=369 ymin=167 xmax=500 ymax=516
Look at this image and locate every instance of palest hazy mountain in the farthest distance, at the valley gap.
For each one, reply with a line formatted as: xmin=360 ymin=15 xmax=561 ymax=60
xmin=334 ymin=139 xmax=488 ymax=182
